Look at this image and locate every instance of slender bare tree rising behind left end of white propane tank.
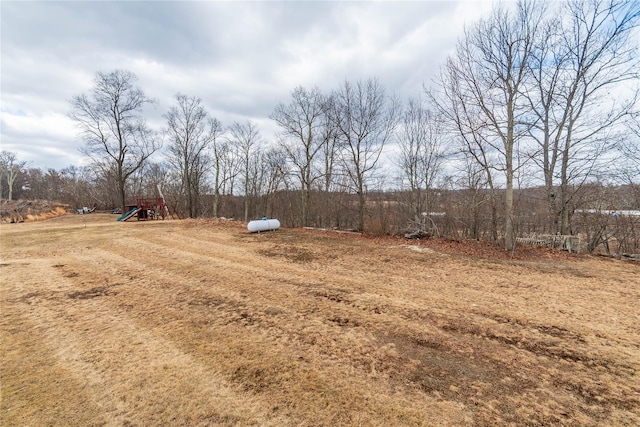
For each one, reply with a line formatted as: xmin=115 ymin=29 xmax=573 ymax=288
xmin=228 ymin=121 xmax=262 ymax=222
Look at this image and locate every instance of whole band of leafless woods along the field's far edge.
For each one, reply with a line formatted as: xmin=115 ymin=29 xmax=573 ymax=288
xmin=0 ymin=0 xmax=640 ymax=254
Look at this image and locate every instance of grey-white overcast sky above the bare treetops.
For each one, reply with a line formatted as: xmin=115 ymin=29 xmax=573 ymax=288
xmin=0 ymin=0 xmax=492 ymax=169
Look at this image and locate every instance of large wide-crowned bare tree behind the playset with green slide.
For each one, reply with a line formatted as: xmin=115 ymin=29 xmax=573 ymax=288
xmin=69 ymin=70 xmax=159 ymax=214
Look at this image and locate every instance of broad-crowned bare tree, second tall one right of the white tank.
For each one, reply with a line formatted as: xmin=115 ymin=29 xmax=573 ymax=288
xmin=331 ymin=79 xmax=398 ymax=231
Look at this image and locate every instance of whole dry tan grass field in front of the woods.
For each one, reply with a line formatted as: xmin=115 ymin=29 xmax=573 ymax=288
xmin=0 ymin=214 xmax=640 ymax=426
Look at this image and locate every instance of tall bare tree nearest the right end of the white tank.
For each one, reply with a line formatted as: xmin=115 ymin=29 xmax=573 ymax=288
xmin=271 ymin=86 xmax=329 ymax=226
